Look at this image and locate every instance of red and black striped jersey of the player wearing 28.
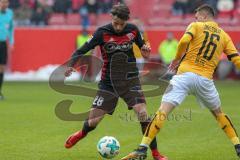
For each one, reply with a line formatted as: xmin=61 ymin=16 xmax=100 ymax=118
xmin=69 ymin=23 xmax=144 ymax=84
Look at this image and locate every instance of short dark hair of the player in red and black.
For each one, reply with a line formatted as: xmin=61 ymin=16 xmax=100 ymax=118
xmin=111 ymin=4 xmax=130 ymax=21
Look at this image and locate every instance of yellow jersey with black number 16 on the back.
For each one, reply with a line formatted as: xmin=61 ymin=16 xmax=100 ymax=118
xmin=178 ymin=21 xmax=240 ymax=79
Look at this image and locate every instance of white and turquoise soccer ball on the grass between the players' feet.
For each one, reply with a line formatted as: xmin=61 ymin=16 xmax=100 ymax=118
xmin=97 ymin=136 xmax=120 ymax=159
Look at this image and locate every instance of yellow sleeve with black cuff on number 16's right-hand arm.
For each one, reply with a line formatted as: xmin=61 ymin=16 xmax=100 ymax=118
xmin=223 ymin=35 xmax=240 ymax=69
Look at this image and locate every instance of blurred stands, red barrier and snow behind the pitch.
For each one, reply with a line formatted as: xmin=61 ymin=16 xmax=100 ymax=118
xmin=5 ymin=0 xmax=240 ymax=80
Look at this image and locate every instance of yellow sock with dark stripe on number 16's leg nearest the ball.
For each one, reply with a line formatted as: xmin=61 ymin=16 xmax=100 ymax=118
xmin=141 ymin=111 xmax=167 ymax=146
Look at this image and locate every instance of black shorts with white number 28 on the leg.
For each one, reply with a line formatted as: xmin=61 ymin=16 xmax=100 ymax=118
xmin=92 ymin=78 xmax=146 ymax=114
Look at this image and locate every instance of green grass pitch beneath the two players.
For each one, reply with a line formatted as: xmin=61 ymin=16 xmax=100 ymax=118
xmin=0 ymin=81 xmax=240 ymax=160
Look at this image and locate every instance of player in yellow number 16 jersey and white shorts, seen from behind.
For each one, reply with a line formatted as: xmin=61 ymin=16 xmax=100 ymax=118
xmin=122 ymin=5 xmax=240 ymax=160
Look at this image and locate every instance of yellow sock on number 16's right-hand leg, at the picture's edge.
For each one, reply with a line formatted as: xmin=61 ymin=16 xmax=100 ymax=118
xmin=217 ymin=113 xmax=240 ymax=145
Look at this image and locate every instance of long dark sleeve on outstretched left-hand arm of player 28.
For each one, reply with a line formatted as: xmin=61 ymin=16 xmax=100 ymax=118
xmin=68 ymin=29 xmax=103 ymax=67
